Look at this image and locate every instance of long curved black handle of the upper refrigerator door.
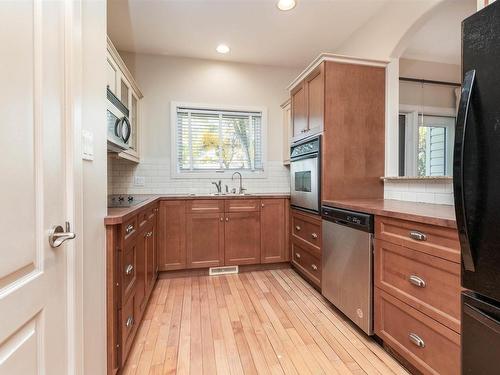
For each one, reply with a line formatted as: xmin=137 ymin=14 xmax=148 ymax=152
xmin=453 ymin=70 xmax=476 ymax=272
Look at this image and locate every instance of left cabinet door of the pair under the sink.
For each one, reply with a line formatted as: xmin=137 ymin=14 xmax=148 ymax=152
xmin=186 ymin=213 xmax=224 ymax=268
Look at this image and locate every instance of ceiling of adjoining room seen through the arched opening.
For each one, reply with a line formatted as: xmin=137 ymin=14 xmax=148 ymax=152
xmin=403 ymin=0 xmax=477 ymax=65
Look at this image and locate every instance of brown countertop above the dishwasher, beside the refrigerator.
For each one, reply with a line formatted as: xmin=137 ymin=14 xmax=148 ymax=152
xmin=323 ymin=199 xmax=457 ymax=228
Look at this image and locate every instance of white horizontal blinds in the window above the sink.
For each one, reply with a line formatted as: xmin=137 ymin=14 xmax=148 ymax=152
xmin=176 ymin=107 xmax=263 ymax=172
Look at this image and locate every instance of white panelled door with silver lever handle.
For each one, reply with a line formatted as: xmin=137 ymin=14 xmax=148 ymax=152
xmin=0 ymin=0 xmax=74 ymax=375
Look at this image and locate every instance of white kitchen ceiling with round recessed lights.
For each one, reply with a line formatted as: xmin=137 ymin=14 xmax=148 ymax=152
xmin=108 ymin=0 xmax=387 ymax=67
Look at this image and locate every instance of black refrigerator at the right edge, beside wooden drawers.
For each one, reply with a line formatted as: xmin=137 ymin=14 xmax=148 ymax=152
xmin=453 ymin=0 xmax=500 ymax=375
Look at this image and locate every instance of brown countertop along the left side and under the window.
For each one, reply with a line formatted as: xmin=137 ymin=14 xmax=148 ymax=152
xmin=104 ymin=193 xmax=290 ymax=225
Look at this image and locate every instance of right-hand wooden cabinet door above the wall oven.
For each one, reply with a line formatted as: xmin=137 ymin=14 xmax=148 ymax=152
xmin=305 ymin=65 xmax=325 ymax=135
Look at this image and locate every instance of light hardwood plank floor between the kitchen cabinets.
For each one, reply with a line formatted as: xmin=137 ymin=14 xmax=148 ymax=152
xmin=124 ymin=269 xmax=407 ymax=375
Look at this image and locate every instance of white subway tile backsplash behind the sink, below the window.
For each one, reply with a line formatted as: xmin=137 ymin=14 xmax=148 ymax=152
xmin=108 ymin=158 xmax=290 ymax=194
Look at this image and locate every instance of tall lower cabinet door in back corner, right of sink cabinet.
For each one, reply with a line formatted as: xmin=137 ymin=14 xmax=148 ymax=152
xmin=260 ymin=199 xmax=288 ymax=263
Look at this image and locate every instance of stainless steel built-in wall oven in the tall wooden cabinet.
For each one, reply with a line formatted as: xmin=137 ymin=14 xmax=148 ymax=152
xmin=290 ymin=135 xmax=321 ymax=213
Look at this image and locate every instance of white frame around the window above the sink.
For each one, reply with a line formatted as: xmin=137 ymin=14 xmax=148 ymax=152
xmin=170 ymin=101 xmax=268 ymax=179
